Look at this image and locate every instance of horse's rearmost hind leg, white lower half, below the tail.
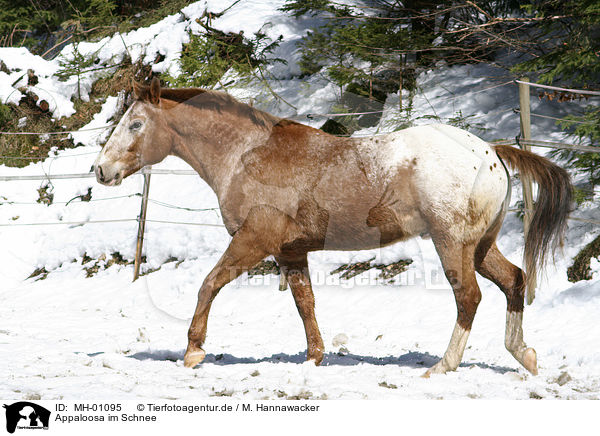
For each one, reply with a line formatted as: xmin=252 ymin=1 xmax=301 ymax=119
xmin=475 ymin=243 xmax=537 ymax=375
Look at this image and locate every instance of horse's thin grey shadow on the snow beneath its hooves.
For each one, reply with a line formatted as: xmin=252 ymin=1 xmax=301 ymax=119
xmin=122 ymin=350 xmax=517 ymax=374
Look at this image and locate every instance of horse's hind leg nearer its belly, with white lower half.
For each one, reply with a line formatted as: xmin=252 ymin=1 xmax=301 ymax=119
xmin=423 ymin=235 xmax=481 ymax=377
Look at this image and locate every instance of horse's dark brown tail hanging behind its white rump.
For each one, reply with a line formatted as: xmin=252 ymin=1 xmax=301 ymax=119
xmin=494 ymin=145 xmax=573 ymax=304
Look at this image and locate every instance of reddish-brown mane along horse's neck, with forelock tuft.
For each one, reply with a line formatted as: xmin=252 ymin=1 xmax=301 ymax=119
xmin=138 ymin=85 xmax=281 ymax=128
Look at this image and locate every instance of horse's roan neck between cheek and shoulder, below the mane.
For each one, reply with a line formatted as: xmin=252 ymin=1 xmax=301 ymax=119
xmin=172 ymin=113 xmax=268 ymax=197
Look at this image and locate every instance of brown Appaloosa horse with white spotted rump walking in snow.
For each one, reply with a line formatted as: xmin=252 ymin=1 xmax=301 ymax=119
xmin=93 ymin=78 xmax=572 ymax=377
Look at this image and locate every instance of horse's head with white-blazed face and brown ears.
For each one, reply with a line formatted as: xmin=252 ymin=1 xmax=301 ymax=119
xmin=94 ymin=78 xmax=172 ymax=186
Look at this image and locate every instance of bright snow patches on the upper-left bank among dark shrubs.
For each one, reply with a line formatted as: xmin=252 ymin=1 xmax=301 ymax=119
xmin=0 ymin=0 xmax=314 ymax=118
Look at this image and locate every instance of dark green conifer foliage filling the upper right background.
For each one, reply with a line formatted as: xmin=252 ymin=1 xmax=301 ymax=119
xmin=282 ymin=0 xmax=600 ymax=184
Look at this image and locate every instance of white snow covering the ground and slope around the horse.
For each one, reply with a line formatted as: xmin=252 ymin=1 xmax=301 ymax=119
xmin=0 ymin=0 xmax=600 ymax=400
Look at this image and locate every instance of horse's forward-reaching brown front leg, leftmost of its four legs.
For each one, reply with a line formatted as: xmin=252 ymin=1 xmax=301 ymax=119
xmin=183 ymin=226 xmax=268 ymax=368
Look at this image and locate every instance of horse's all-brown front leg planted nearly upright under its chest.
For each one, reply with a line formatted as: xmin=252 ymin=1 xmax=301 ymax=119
xmin=277 ymin=254 xmax=325 ymax=365
